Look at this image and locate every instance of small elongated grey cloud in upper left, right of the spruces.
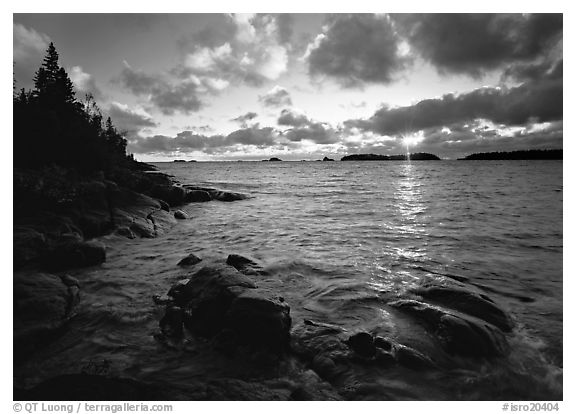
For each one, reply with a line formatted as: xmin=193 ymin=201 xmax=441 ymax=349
xmin=119 ymin=65 xmax=203 ymax=115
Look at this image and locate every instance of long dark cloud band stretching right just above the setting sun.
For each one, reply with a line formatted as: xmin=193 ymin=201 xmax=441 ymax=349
xmin=346 ymin=79 xmax=563 ymax=135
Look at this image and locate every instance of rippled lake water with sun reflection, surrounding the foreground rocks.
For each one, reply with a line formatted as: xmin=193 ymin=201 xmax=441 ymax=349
xmin=16 ymin=161 xmax=563 ymax=399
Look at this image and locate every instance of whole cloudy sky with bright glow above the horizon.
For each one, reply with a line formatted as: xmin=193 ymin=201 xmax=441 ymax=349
xmin=13 ymin=13 xmax=563 ymax=161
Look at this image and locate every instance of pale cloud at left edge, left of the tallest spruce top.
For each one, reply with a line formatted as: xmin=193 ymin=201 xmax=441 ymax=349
xmin=12 ymin=23 xmax=50 ymax=88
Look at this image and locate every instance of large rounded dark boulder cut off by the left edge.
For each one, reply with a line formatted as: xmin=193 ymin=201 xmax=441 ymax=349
xmin=13 ymin=273 xmax=79 ymax=359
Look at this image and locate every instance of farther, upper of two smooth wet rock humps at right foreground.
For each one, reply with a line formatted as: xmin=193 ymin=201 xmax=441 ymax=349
xmin=414 ymin=286 xmax=513 ymax=332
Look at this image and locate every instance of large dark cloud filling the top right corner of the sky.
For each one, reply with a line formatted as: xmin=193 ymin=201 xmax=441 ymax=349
xmin=391 ymin=13 xmax=563 ymax=77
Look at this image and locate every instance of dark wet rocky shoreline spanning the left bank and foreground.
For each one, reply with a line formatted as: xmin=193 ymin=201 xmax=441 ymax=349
xmin=14 ymin=166 xmax=514 ymax=400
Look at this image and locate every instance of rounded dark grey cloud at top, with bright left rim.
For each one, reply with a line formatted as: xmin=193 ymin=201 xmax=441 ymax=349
xmin=308 ymin=14 xmax=408 ymax=87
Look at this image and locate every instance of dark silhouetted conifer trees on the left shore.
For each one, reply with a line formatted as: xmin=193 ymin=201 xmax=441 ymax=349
xmin=13 ymin=43 xmax=133 ymax=174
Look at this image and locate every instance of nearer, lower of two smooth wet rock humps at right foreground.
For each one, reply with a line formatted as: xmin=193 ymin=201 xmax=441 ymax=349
xmin=390 ymin=300 xmax=509 ymax=357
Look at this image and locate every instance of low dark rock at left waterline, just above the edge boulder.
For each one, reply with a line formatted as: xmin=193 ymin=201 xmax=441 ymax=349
xmin=42 ymin=241 xmax=106 ymax=271
